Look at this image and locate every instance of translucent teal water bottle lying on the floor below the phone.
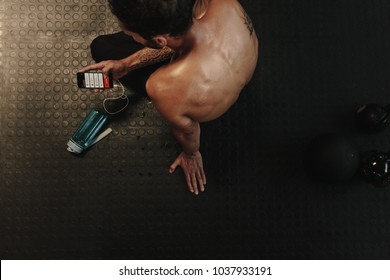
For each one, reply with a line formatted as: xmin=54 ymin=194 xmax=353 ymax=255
xmin=68 ymin=109 xmax=112 ymax=154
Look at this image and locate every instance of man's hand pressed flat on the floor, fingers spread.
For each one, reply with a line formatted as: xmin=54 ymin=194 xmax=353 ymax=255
xmin=169 ymin=151 xmax=206 ymax=195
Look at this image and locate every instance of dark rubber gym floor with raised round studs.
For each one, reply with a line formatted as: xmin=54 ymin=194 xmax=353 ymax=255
xmin=0 ymin=0 xmax=390 ymax=259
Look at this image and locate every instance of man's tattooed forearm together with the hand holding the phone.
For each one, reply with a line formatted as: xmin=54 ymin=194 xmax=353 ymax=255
xmin=80 ymin=47 xmax=174 ymax=79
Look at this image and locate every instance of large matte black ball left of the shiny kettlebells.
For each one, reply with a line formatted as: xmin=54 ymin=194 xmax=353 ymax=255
xmin=306 ymin=134 xmax=359 ymax=183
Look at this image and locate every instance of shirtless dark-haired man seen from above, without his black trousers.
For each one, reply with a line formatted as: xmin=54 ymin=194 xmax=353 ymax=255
xmin=81 ymin=0 xmax=258 ymax=194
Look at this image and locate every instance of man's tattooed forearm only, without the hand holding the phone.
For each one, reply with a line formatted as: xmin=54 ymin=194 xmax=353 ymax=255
xmin=122 ymin=47 xmax=174 ymax=71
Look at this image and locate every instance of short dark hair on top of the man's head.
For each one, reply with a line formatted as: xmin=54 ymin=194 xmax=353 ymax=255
xmin=108 ymin=0 xmax=195 ymax=39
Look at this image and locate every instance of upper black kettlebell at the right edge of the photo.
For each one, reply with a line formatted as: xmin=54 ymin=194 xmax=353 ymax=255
xmin=356 ymin=104 xmax=390 ymax=134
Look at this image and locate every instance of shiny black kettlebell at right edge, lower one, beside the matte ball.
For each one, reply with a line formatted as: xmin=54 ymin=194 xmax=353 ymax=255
xmin=360 ymin=151 xmax=390 ymax=187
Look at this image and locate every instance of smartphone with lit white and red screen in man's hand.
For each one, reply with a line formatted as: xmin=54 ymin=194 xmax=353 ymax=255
xmin=77 ymin=72 xmax=113 ymax=89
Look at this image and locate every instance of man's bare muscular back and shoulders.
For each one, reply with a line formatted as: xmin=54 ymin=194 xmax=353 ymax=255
xmin=149 ymin=0 xmax=258 ymax=122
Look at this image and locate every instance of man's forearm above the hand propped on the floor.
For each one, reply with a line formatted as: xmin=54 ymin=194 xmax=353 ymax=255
xmin=172 ymin=122 xmax=200 ymax=155
